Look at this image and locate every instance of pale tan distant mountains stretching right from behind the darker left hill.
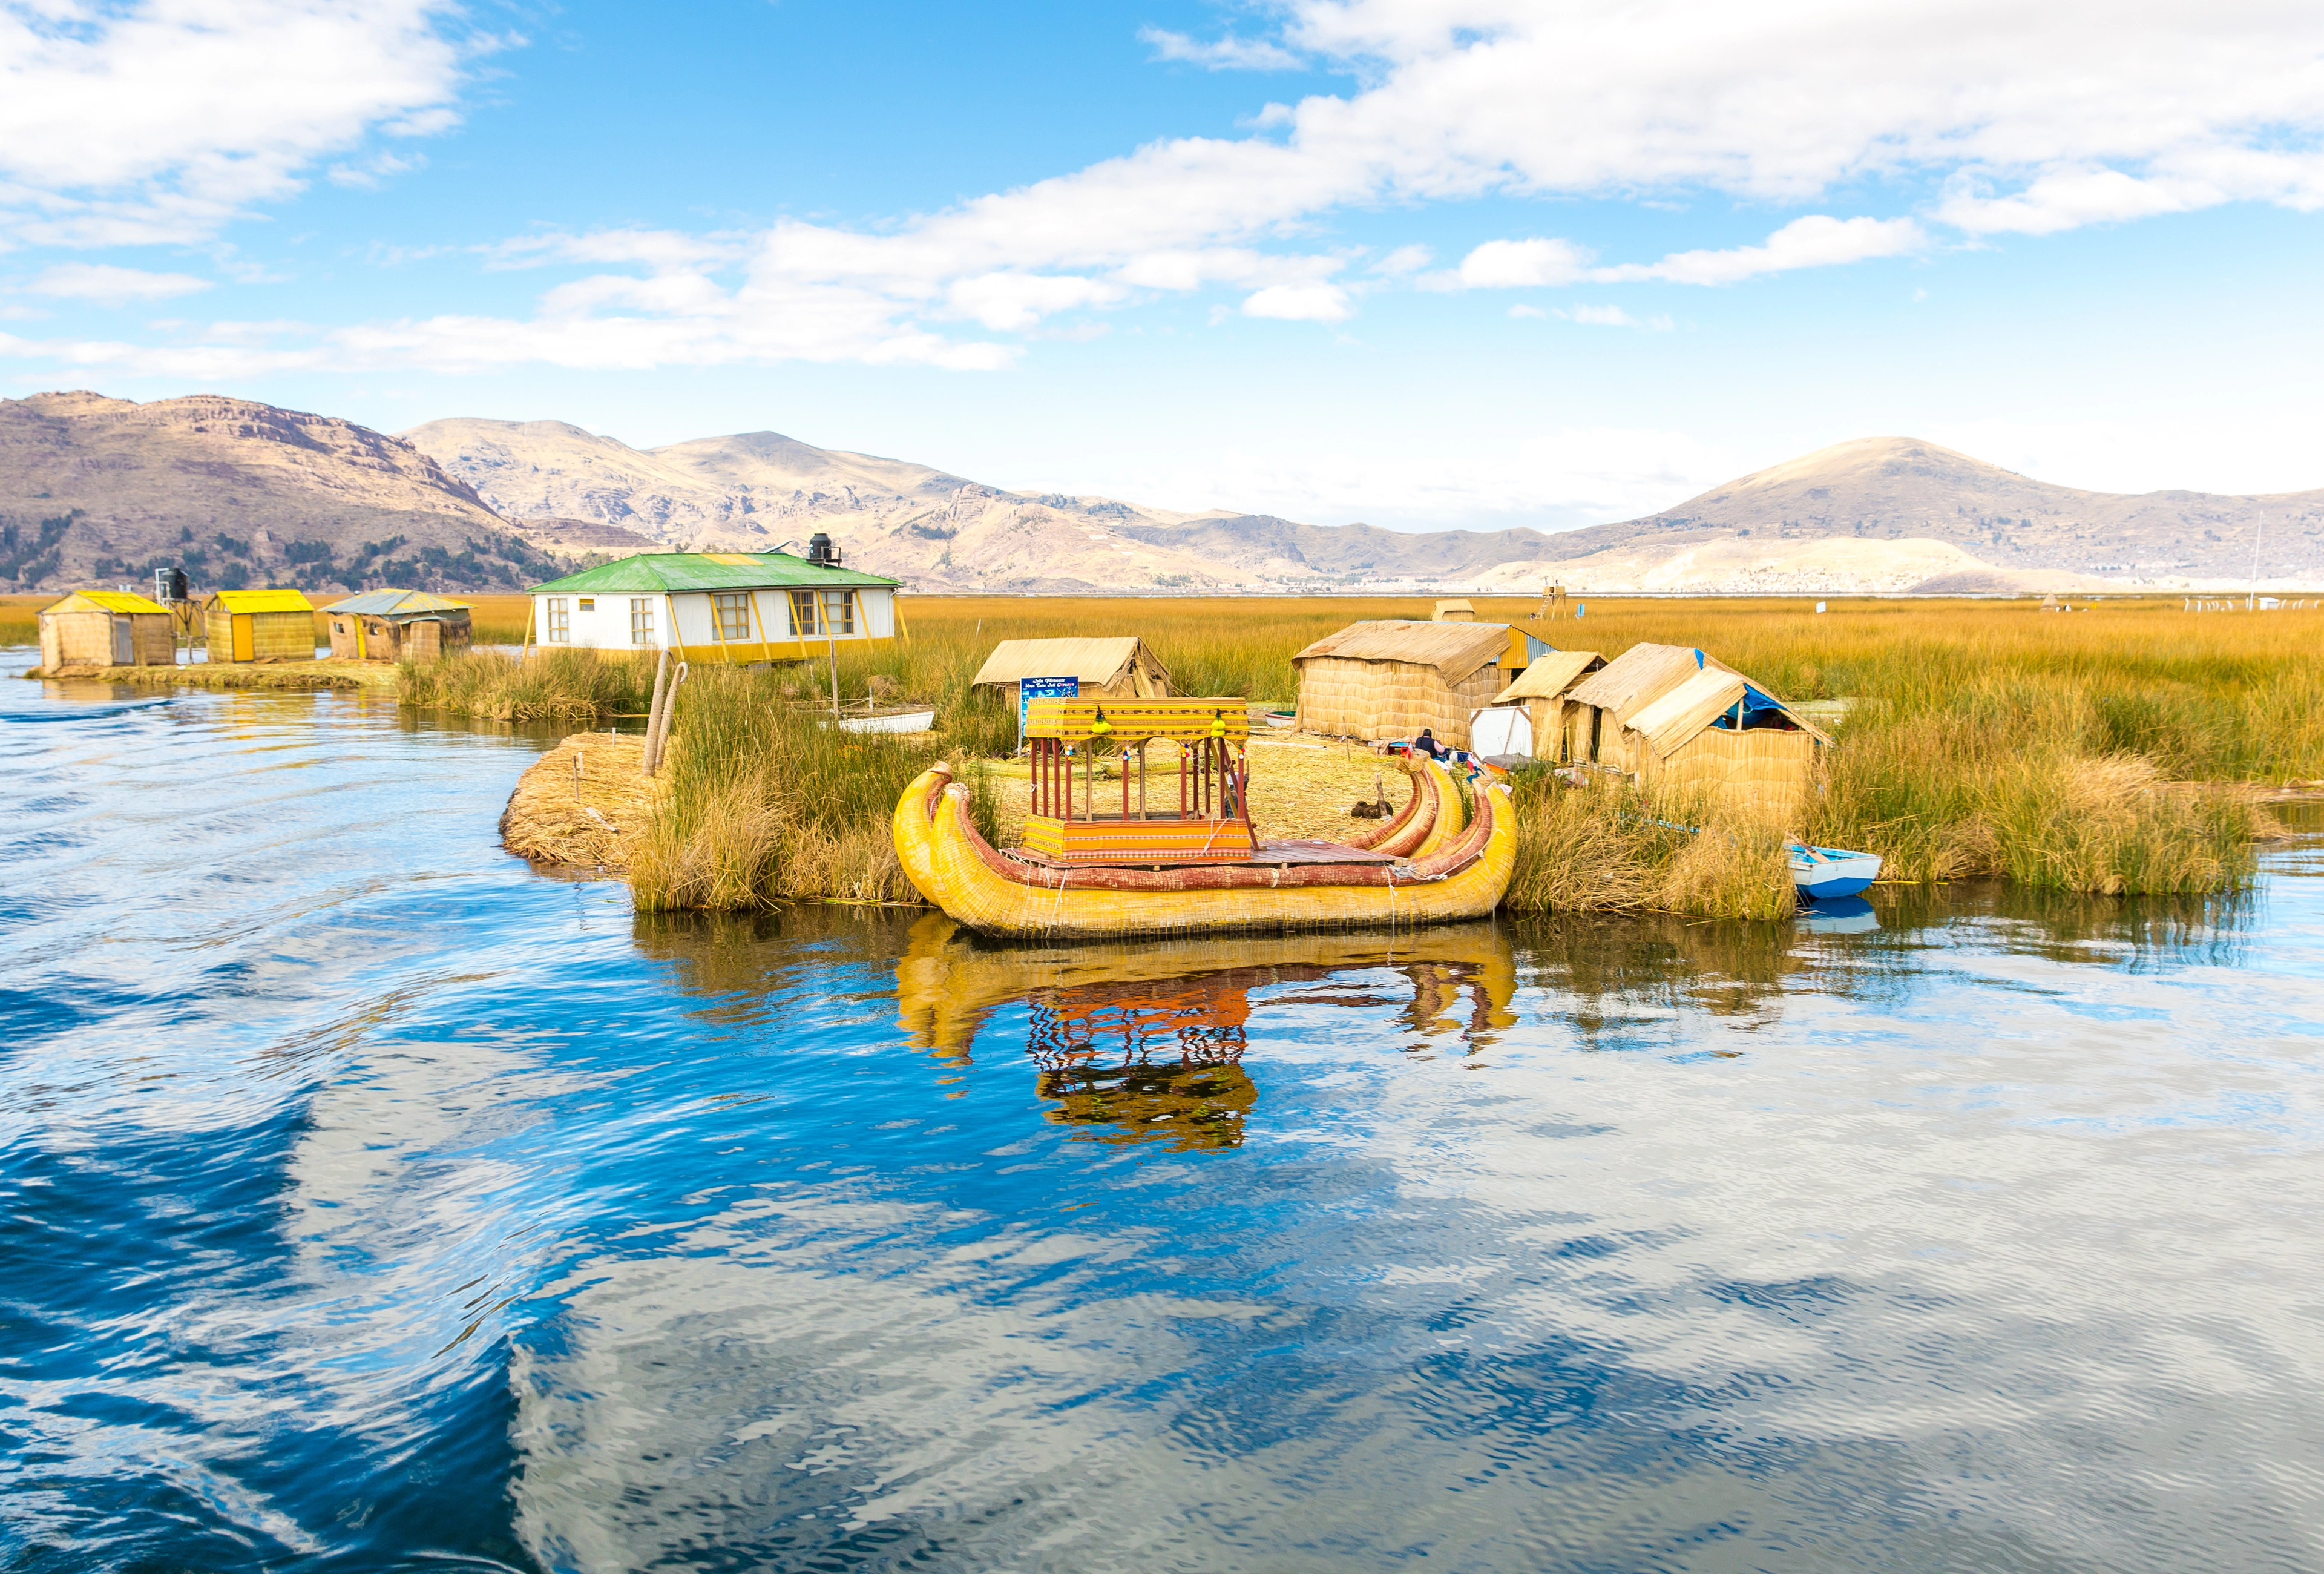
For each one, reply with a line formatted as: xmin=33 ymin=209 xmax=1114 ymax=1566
xmin=404 ymin=421 xmax=2324 ymax=593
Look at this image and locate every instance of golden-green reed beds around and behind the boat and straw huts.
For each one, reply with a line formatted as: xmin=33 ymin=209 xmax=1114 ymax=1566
xmin=462 ymin=598 xmax=2324 ymax=918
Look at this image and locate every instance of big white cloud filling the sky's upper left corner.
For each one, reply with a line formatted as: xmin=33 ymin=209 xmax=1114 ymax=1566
xmin=0 ymin=0 xmax=481 ymax=246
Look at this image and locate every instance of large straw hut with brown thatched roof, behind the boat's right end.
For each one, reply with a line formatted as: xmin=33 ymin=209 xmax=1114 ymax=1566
xmin=1292 ymin=619 xmax=1548 ymax=749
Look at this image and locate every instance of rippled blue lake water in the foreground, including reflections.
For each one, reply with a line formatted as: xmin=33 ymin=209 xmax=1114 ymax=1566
xmin=13 ymin=653 xmax=2324 ymax=1572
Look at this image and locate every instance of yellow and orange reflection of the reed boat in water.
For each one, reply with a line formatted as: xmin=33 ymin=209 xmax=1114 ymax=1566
xmin=894 ymin=914 xmax=1518 ymax=1153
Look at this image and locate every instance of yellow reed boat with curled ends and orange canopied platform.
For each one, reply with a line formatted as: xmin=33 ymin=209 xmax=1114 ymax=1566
xmin=894 ymin=700 xmax=1518 ymax=940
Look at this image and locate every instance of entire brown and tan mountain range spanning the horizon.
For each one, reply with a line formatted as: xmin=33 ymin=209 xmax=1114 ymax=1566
xmin=0 ymin=393 xmax=2324 ymax=595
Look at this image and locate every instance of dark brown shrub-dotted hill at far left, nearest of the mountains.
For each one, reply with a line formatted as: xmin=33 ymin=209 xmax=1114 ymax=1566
xmin=0 ymin=393 xmax=560 ymax=593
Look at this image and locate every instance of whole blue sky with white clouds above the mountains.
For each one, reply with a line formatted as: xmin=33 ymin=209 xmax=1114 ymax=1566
xmin=0 ymin=0 xmax=2324 ymax=530
